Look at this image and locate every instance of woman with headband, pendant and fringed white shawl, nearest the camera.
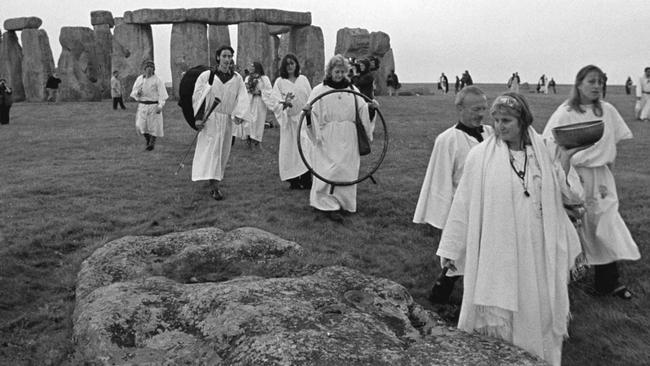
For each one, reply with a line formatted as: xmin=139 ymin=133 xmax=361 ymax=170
xmin=437 ymin=92 xmax=582 ymax=365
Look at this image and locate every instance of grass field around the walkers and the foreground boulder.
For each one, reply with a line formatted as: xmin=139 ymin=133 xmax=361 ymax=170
xmin=0 ymin=84 xmax=650 ymax=365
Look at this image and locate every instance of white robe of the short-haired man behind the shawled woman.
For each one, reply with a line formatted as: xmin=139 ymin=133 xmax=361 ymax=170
xmin=413 ymin=125 xmax=494 ymax=229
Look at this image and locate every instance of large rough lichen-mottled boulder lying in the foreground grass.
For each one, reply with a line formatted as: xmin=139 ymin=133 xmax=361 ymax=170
xmin=74 ymin=228 xmax=544 ymax=366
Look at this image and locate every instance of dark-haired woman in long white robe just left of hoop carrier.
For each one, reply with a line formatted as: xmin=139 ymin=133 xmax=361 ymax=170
xmin=267 ymin=54 xmax=312 ymax=189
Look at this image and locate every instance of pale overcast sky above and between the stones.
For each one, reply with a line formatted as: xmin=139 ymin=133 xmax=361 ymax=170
xmin=0 ymin=0 xmax=650 ymax=84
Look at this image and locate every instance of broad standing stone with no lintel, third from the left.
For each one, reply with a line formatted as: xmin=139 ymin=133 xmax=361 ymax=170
xmin=59 ymin=27 xmax=101 ymax=101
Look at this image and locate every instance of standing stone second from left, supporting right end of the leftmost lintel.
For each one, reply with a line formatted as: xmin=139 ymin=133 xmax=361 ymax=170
xmin=20 ymin=29 xmax=54 ymax=102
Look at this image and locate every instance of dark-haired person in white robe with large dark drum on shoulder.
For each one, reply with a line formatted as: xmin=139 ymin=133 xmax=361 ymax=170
xmin=192 ymin=46 xmax=249 ymax=200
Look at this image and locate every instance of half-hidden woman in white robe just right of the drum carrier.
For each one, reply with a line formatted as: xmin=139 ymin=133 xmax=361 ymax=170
xmin=232 ymin=62 xmax=271 ymax=147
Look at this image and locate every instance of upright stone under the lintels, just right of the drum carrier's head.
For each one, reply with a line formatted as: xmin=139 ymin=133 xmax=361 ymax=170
xmin=237 ymin=22 xmax=273 ymax=80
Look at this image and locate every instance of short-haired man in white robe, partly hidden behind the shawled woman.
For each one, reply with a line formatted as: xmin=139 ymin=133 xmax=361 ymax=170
xmin=413 ymin=85 xmax=494 ymax=303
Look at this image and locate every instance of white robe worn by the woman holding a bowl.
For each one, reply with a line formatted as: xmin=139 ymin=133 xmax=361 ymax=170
xmin=544 ymin=100 xmax=641 ymax=264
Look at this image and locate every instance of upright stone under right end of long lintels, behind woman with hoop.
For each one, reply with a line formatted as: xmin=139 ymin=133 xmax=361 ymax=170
xmin=289 ymin=25 xmax=325 ymax=87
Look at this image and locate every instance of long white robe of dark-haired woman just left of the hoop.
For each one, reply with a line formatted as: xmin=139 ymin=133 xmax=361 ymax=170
xmin=267 ymin=75 xmax=312 ymax=180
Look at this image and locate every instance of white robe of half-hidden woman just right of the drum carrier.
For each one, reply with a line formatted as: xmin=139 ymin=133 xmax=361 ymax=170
xmin=232 ymin=75 xmax=271 ymax=142
